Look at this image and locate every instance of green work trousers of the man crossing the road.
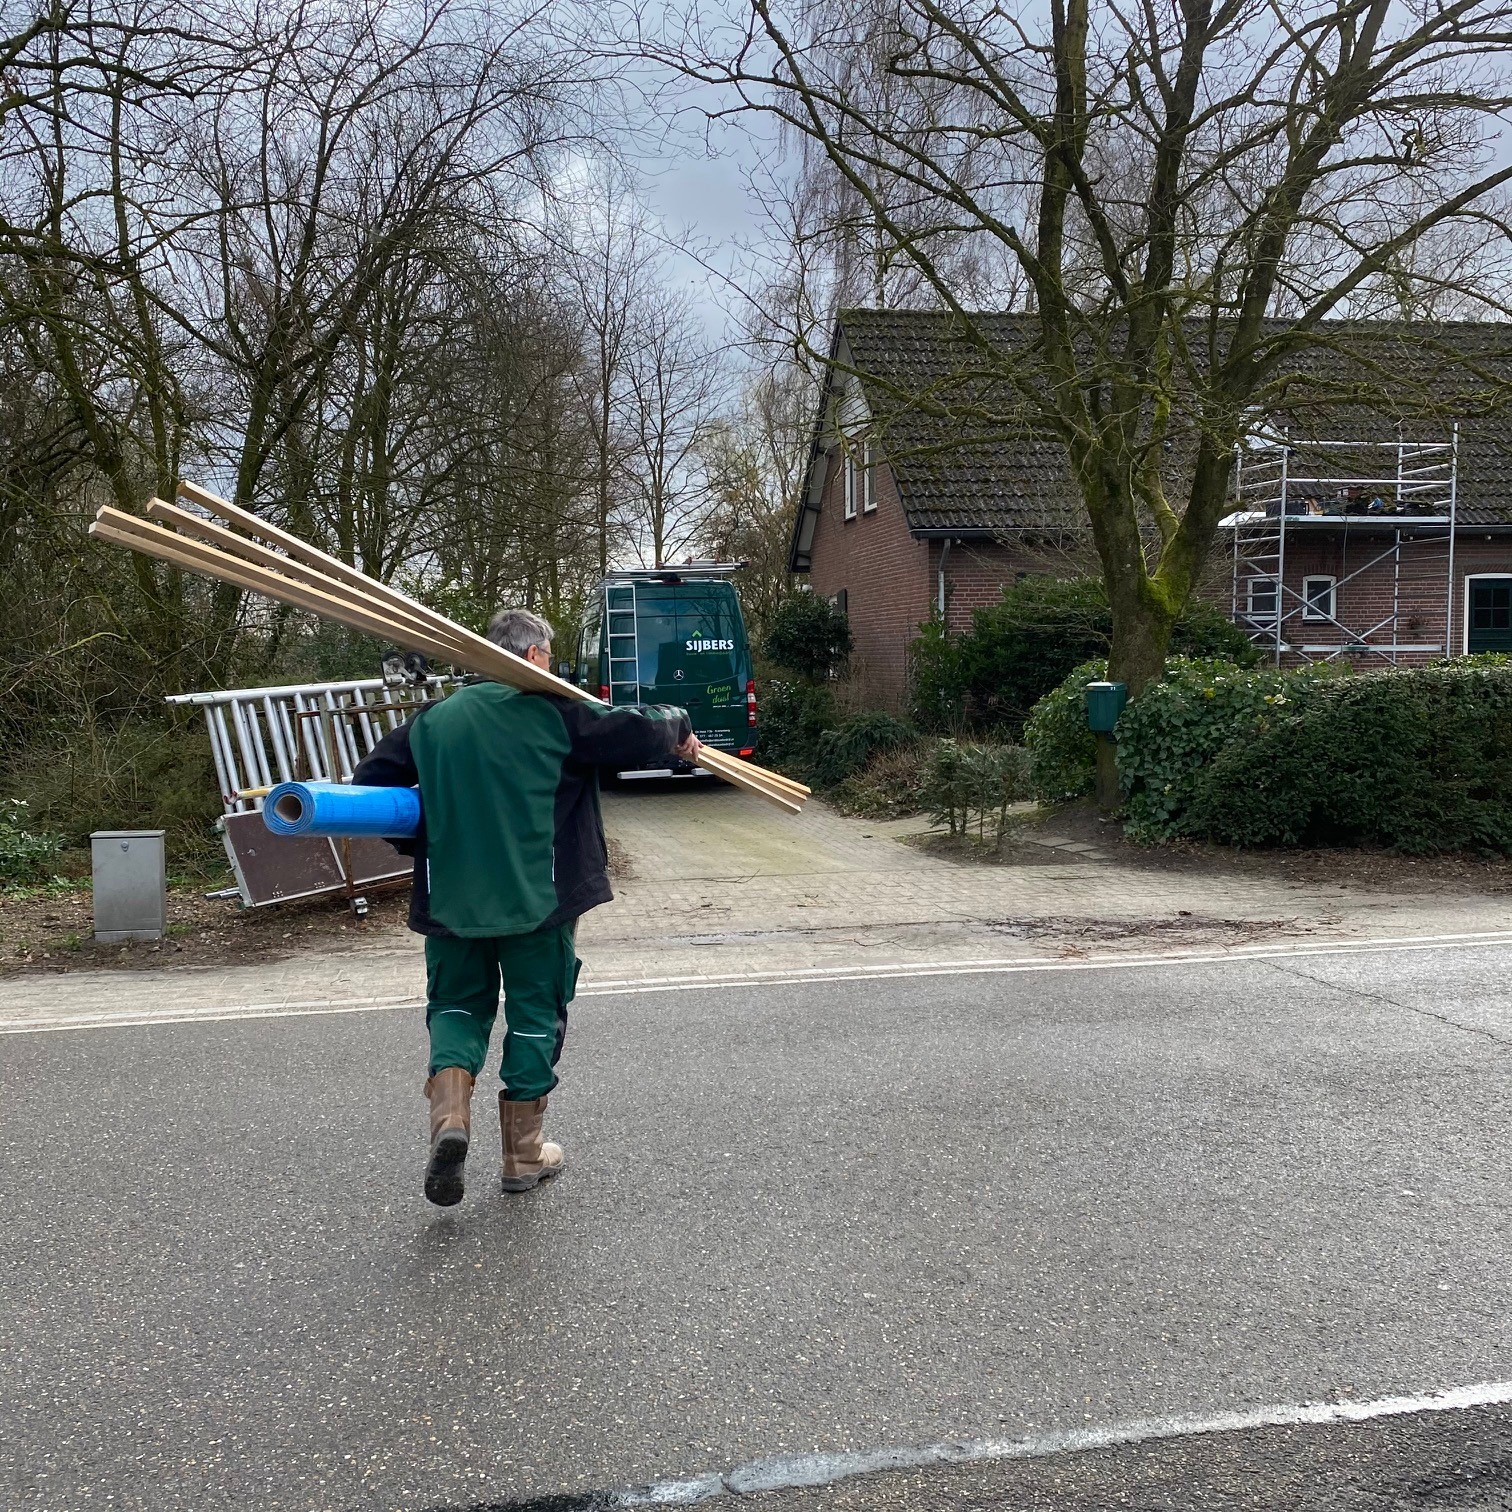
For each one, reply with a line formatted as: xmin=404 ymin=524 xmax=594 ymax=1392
xmin=425 ymin=924 xmax=582 ymax=1102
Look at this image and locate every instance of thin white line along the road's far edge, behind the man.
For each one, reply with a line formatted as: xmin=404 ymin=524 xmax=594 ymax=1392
xmin=0 ymin=930 xmax=1512 ymax=1034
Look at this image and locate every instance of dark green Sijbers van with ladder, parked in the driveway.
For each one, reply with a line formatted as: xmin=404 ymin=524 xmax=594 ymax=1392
xmin=575 ymin=562 xmax=756 ymax=777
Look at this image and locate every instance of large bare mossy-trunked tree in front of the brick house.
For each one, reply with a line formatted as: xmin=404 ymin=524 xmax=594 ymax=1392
xmin=623 ymin=0 xmax=1512 ymax=782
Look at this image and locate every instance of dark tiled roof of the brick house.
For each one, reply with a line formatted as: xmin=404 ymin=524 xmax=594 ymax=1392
xmin=839 ymin=310 xmax=1512 ymax=534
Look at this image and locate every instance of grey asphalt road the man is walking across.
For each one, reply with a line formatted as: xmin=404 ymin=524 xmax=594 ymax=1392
xmin=0 ymin=947 xmax=1512 ymax=1512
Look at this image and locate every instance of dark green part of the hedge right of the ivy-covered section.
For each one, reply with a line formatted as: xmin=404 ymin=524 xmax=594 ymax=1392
xmin=1172 ymin=659 xmax=1512 ymax=854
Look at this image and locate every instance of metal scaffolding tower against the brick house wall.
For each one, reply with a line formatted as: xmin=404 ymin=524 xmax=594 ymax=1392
xmin=1220 ymin=425 xmax=1459 ymax=665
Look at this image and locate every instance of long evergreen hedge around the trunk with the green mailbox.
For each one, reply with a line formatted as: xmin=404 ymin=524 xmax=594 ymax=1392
xmin=1025 ymin=656 xmax=1512 ymax=854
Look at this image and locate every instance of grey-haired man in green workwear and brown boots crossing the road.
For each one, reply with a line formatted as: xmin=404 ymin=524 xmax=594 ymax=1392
xmin=352 ymin=609 xmax=699 ymax=1207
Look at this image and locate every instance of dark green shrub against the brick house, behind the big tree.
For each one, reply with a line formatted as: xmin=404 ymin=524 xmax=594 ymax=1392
xmin=912 ymin=576 xmax=1256 ymax=735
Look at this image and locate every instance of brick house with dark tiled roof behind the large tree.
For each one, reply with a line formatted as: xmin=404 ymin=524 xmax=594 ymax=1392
xmin=789 ymin=310 xmax=1512 ymax=708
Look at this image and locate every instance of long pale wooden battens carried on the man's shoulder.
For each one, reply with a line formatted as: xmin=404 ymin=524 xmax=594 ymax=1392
xmin=89 ymin=482 xmax=809 ymax=813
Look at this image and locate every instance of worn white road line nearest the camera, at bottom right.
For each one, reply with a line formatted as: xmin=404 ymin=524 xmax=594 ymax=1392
xmin=605 ymin=1380 xmax=1512 ymax=1507
